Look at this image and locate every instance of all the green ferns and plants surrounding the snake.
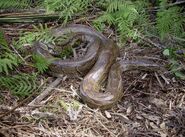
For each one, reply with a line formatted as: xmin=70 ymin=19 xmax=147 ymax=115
xmin=0 ymin=0 xmax=185 ymax=96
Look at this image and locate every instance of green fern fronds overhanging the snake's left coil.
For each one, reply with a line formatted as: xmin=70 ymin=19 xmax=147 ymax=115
xmin=14 ymin=24 xmax=72 ymax=73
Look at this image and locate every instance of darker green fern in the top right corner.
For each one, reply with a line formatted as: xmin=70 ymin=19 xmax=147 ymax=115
xmin=157 ymin=7 xmax=184 ymax=39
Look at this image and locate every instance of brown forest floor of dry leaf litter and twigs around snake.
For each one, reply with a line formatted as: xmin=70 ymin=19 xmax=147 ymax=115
xmin=0 ymin=22 xmax=185 ymax=137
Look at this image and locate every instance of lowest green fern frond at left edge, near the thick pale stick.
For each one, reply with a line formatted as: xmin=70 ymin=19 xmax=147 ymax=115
xmin=0 ymin=74 xmax=37 ymax=97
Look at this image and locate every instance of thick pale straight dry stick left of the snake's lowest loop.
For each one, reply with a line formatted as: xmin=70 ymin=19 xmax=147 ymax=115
xmin=28 ymin=78 xmax=62 ymax=106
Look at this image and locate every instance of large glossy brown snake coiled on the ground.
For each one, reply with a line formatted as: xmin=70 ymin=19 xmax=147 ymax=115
xmin=34 ymin=24 xmax=159 ymax=109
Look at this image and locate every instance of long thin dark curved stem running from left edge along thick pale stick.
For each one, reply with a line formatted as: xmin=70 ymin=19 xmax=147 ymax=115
xmin=0 ymin=80 xmax=47 ymax=119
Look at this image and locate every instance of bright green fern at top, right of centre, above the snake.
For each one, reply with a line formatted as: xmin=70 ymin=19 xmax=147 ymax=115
xmin=94 ymin=0 xmax=139 ymax=40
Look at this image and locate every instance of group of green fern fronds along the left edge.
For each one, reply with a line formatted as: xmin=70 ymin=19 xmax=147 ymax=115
xmin=0 ymin=28 xmax=37 ymax=98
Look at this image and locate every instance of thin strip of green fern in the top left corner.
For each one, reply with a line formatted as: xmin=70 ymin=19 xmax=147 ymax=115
xmin=0 ymin=0 xmax=30 ymax=9
